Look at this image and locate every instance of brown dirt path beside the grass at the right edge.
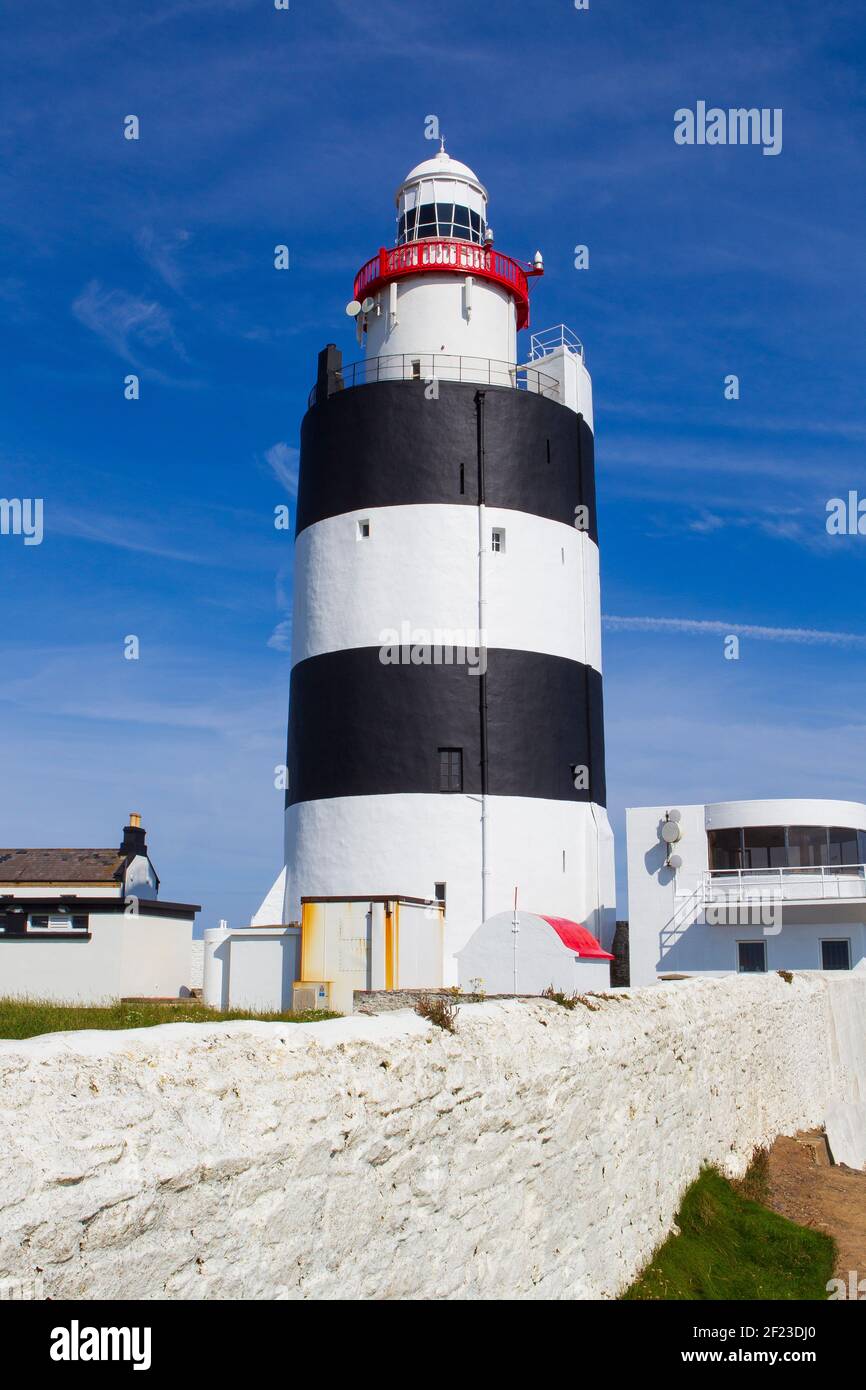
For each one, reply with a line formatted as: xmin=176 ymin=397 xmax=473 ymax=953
xmin=766 ymin=1134 xmax=866 ymax=1279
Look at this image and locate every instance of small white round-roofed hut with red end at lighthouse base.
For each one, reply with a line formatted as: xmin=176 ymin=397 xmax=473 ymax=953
xmin=457 ymin=912 xmax=613 ymax=994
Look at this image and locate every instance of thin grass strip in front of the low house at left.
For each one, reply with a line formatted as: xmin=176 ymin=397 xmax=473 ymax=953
xmin=0 ymin=998 xmax=341 ymax=1038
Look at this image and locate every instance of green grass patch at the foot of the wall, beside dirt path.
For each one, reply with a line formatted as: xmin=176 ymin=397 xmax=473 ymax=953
xmin=623 ymin=1168 xmax=835 ymax=1301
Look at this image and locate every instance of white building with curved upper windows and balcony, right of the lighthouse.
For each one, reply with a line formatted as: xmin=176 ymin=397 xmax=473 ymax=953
xmin=626 ymin=799 xmax=866 ymax=986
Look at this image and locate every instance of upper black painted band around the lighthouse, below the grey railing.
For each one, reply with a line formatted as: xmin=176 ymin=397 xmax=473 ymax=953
xmin=297 ymin=381 xmax=598 ymax=541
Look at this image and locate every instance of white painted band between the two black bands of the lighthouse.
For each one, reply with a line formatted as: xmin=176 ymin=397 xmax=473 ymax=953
xmin=292 ymin=505 xmax=602 ymax=671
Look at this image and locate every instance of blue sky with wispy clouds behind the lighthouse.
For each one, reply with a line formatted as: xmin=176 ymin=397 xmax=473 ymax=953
xmin=0 ymin=0 xmax=866 ymax=926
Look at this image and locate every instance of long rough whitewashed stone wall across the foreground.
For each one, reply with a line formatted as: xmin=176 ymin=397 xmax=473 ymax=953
xmin=0 ymin=976 xmax=866 ymax=1298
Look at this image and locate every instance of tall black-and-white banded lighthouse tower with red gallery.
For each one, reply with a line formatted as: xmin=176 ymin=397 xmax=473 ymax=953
xmin=271 ymin=149 xmax=614 ymax=981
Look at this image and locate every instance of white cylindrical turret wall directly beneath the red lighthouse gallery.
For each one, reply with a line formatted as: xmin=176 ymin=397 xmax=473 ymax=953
xmin=366 ymin=271 xmax=517 ymax=366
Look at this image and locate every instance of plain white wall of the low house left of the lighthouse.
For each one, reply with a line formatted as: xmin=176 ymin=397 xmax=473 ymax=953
xmin=0 ymin=912 xmax=192 ymax=1004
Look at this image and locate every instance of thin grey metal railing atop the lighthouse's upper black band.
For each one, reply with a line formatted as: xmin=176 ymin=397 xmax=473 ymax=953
xmin=309 ymin=352 xmax=559 ymax=406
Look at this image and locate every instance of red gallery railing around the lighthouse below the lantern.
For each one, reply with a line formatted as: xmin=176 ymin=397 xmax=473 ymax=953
xmin=354 ymin=238 xmax=541 ymax=328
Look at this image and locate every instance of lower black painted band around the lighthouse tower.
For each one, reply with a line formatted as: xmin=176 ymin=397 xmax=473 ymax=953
xmin=286 ymin=646 xmax=606 ymax=806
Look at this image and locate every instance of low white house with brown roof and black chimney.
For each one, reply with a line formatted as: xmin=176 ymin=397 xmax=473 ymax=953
xmin=0 ymin=816 xmax=199 ymax=1004
